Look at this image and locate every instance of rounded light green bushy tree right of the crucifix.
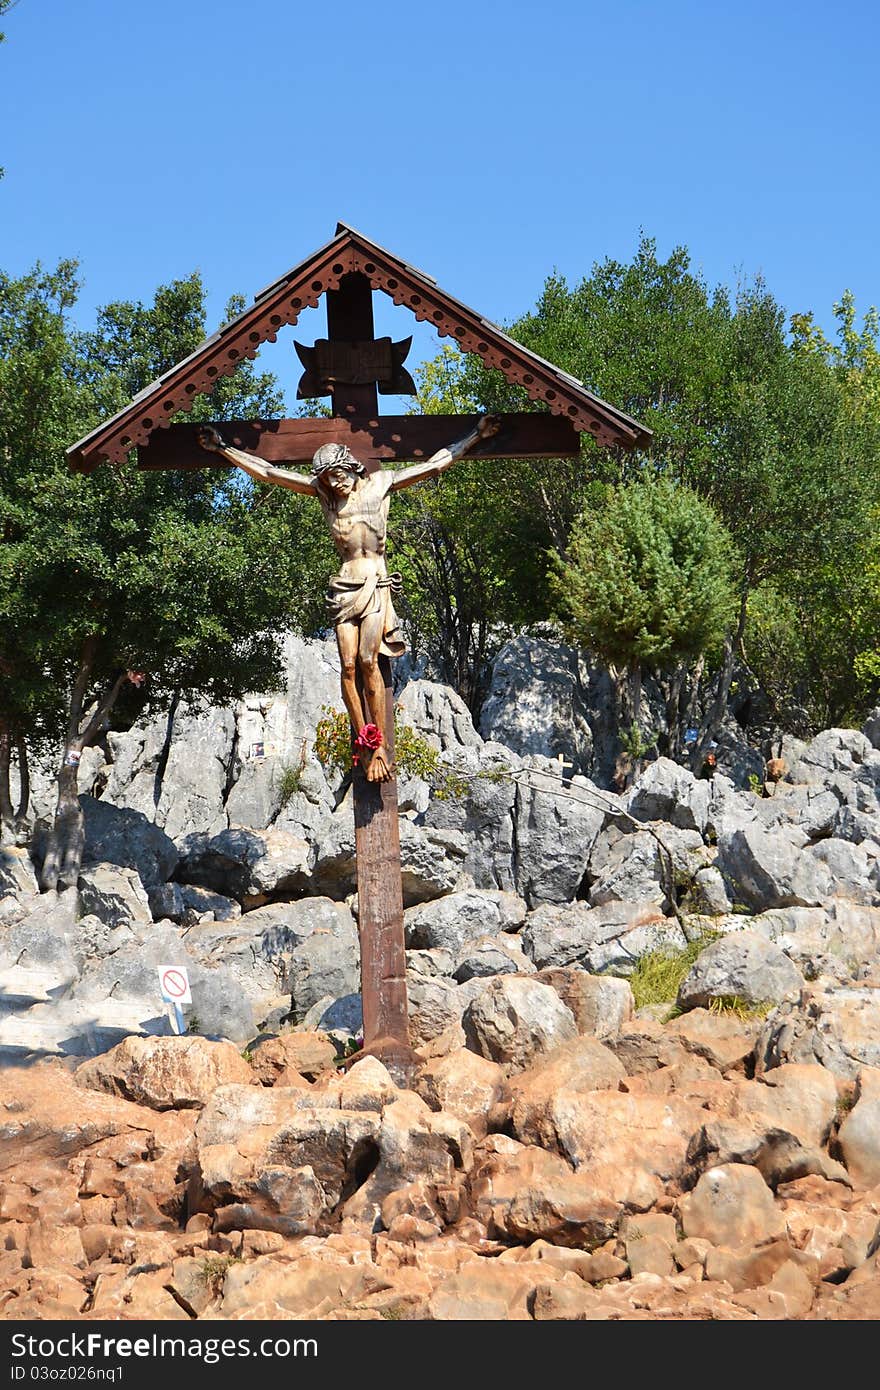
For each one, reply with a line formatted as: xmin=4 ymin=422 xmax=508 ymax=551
xmin=552 ymin=478 xmax=735 ymax=772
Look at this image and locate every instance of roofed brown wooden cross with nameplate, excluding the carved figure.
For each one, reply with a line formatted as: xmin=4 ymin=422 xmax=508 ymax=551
xmin=68 ymin=224 xmax=651 ymax=1073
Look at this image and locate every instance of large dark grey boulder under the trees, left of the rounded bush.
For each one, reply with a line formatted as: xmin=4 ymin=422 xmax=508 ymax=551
xmin=480 ymin=637 xmax=592 ymax=773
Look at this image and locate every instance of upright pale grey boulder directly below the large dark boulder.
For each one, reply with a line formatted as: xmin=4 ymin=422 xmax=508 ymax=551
xmin=514 ymin=756 xmax=609 ymax=906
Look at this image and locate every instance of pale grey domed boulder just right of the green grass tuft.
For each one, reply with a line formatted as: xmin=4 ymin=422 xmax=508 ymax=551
xmin=677 ymin=931 xmax=804 ymax=1009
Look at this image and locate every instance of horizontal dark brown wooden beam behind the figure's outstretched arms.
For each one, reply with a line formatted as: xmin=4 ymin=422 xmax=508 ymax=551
xmin=138 ymin=411 xmax=580 ymax=468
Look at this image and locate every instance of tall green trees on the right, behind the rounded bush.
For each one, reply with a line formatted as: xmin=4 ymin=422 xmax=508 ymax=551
xmin=462 ymin=238 xmax=880 ymax=745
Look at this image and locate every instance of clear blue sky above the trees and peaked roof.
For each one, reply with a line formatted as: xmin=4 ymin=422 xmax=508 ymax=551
xmin=0 ymin=0 xmax=880 ymax=405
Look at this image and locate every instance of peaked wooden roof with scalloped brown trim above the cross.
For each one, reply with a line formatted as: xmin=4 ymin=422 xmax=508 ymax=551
xmin=67 ymin=222 xmax=651 ymax=473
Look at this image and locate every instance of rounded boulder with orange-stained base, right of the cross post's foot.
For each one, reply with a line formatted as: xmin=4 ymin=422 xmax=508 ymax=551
xmin=462 ymin=974 xmax=577 ymax=1068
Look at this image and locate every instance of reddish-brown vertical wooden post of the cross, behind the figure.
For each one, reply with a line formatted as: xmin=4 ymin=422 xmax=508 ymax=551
xmin=327 ymin=274 xmax=409 ymax=1052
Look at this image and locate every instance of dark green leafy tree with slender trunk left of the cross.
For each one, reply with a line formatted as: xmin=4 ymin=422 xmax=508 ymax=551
xmin=0 ymin=263 xmax=329 ymax=887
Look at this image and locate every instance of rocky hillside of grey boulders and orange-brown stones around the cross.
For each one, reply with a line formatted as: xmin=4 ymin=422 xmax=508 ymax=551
xmin=0 ymin=639 xmax=880 ymax=1319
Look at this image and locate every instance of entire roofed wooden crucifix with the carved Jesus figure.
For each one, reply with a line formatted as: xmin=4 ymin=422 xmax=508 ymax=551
xmin=68 ymin=224 xmax=651 ymax=1074
